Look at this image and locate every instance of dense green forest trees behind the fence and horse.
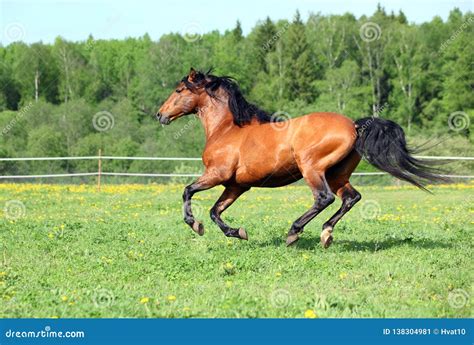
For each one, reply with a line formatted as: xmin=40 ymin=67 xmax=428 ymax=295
xmin=0 ymin=6 xmax=474 ymax=173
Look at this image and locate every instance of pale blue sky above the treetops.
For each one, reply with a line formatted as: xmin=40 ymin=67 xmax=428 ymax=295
xmin=0 ymin=0 xmax=473 ymax=45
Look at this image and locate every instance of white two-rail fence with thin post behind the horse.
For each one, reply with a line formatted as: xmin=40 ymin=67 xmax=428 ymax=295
xmin=0 ymin=154 xmax=474 ymax=180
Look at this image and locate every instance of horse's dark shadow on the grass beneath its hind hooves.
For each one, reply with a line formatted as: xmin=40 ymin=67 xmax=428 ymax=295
xmin=258 ymin=235 xmax=452 ymax=252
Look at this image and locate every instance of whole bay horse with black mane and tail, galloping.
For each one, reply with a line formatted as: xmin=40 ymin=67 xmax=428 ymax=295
xmin=156 ymin=68 xmax=442 ymax=248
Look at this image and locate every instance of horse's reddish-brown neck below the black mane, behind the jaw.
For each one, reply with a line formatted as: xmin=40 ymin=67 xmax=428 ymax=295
xmin=198 ymin=98 xmax=235 ymax=140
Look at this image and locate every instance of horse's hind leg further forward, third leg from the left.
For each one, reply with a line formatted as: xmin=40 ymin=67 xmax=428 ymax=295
xmin=286 ymin=171 xmax=335 ymax=246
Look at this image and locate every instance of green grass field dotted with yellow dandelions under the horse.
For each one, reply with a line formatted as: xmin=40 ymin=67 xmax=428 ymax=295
xmin=0 ymin=183 xmax=474 ymax=318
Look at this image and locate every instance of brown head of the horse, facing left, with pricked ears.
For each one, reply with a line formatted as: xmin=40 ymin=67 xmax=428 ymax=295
xmin=156 ymin=68 xmax=206 ymax=125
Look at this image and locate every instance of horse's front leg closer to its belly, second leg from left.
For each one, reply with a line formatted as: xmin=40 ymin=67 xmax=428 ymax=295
xmin=211 ymin=185 xmax=249 ymax=240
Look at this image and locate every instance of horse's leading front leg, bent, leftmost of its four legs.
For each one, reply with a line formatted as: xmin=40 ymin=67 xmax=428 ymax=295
xmin=183 ymin=173 xmax=222 ymax=236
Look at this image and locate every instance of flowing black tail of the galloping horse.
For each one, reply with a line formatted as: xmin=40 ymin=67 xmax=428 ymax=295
xmin=355 ymin=117 xmax=448 ymax=190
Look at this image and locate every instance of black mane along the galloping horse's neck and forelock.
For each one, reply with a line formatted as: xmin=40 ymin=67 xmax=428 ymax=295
xmin=182 ymin=70 xmax=281 ymax=127
